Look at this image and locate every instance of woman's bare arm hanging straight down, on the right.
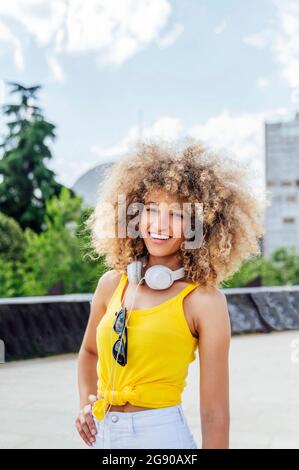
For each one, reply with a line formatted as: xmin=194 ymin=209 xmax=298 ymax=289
xmin=192 ymin=288 xmax=231 ymax=449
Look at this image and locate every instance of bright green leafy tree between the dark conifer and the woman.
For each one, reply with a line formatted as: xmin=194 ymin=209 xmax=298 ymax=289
xmin=23 ymin=188 xmax=106 ymax=295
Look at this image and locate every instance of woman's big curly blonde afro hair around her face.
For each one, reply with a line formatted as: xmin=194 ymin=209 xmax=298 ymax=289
xmin=86 ymin=138 xmax=265 ymax=287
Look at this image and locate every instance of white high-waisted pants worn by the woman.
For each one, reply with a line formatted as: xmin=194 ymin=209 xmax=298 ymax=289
xmin=89 ymin=404 xmax=198 ymax=449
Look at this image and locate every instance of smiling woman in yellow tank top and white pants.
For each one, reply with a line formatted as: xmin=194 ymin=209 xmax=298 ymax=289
xmin=76 ymin=142 xmax=263 ymax=449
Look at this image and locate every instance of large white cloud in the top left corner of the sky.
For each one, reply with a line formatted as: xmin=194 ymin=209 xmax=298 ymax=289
xmin=0 ymin=0 xmax=182 ymax=81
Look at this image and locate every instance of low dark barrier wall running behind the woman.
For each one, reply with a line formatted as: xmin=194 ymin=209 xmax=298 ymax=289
xmin=0 ymin=286 xmax=299 ymax=362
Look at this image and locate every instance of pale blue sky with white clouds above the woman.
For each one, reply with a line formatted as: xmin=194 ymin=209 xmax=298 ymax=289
xmin=0 ymin=0 xmax=299 ymax=191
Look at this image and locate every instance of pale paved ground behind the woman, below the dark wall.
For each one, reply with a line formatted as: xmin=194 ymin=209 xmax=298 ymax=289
xmin=0 ymin=330 xmax=299 ymax=449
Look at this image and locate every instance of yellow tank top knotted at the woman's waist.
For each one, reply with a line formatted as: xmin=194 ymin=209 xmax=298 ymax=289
xmin=92 ymin=273 xmax=198 ymax=420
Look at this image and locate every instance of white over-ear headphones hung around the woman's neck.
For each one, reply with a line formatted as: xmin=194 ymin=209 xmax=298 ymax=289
xmin=127 ymin=255 xmax=185 ymax=290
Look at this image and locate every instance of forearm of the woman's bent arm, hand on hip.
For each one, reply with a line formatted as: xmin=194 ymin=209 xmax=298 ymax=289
xmin=77 ymin=348 xmax=98 ymax=408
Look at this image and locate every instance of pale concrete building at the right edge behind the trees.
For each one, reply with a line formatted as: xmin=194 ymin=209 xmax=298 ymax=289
xmin=263 ymin=113 xmax=299 ymax=257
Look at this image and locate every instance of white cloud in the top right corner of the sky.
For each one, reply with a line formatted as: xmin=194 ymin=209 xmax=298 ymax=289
xmin=243 ymin=0 xmax=299 ymax=96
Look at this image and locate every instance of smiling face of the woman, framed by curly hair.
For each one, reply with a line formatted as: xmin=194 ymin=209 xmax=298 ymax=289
xmin=139 ymin=190 xmax=190 ymax=256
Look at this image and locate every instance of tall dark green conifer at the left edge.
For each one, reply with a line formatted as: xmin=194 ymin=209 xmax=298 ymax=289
xmin=0 ymin=82 xmax=72 ymax=233
